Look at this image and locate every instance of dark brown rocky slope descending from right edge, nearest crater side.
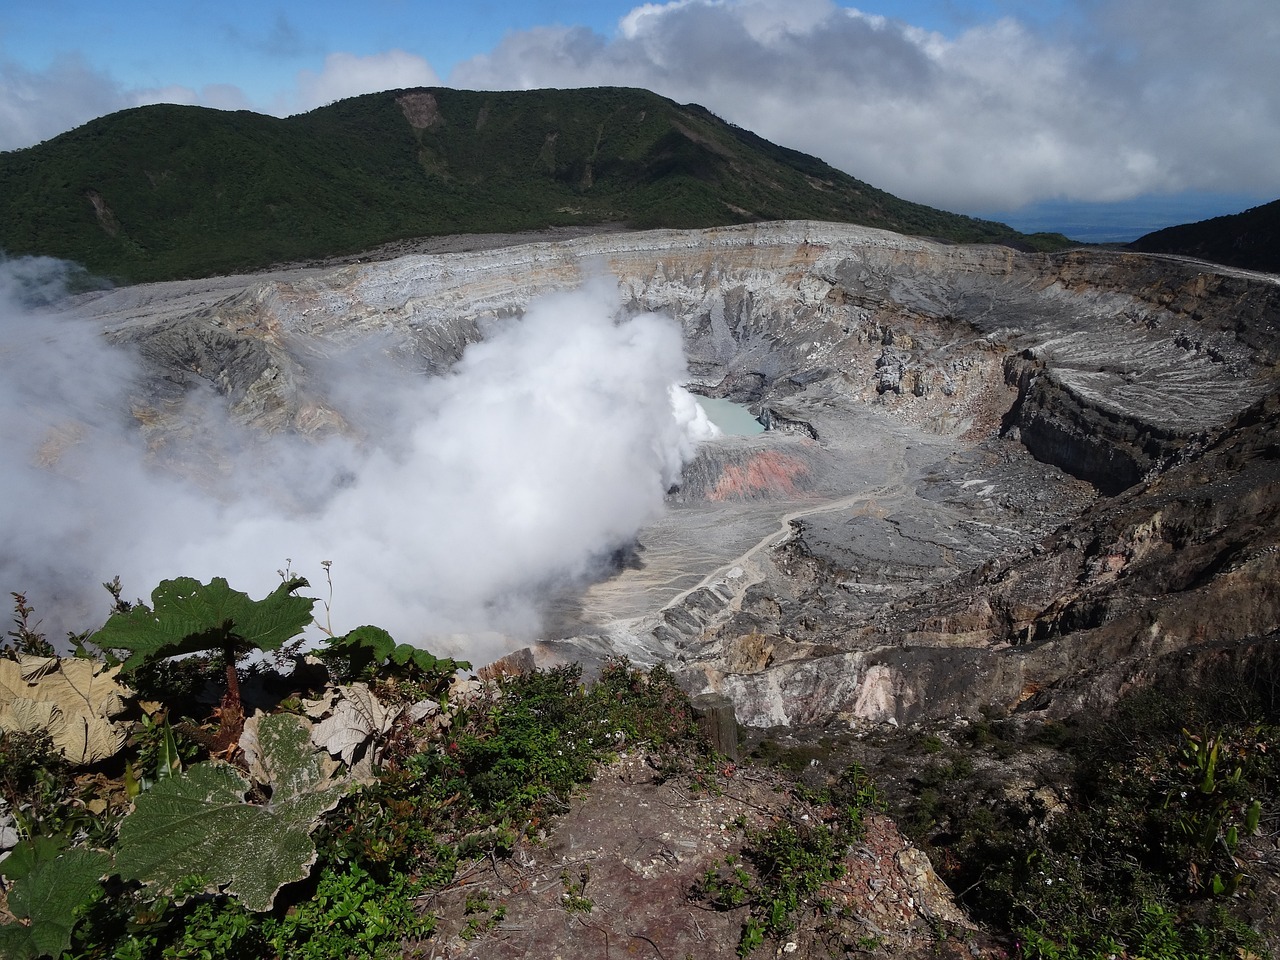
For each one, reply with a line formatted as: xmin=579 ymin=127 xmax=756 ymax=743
xmin=691 ymin=394 xmax=1280 ymax=726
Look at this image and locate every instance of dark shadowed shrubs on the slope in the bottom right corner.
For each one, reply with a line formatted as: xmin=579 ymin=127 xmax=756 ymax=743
xmin=870 ymin=663 xmax=1280 ymax=960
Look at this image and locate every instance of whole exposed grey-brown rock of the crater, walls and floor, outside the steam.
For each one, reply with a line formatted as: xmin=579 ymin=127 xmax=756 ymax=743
xmin=77 ymin=223 xmax=1280 ymax=724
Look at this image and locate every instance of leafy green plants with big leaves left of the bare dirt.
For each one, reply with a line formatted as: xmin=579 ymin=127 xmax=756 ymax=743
xmin=0 ymin=580 xmax=699 ymax=960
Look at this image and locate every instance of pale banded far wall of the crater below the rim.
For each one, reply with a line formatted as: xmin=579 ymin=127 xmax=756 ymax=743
xmin=95 ymin=223 xmax=1280 ymax=492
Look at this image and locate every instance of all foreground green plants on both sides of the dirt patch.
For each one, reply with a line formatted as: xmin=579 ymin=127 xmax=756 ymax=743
xmin=0 ymin=579 xmax=1280 ymax=960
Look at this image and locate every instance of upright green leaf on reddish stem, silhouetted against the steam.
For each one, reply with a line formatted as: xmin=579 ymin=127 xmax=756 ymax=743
xmin=90 ymin=577 xmax=315 ymax=672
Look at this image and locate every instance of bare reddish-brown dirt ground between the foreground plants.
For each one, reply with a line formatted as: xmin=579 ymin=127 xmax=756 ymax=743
xmin=424 ymin=753 xmax=1002 ymax=960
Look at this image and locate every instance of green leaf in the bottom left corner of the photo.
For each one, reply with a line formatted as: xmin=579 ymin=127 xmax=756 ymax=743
xmin=0 ymin=849 xmax=111 ymax=960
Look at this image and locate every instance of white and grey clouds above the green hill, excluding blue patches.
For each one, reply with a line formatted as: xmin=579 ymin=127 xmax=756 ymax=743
xmin=0 ymin=0 xmax=1280 ymax=212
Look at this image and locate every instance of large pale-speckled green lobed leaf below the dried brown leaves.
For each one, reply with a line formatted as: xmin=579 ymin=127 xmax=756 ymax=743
xmin=116 ymin=714 xmax=346 ymax=911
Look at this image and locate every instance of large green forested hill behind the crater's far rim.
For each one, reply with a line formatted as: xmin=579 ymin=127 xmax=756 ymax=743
xmin=0 ymin=87 xmax=1066 ymax=282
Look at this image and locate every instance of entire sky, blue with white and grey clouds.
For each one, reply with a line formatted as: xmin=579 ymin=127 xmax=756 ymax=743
xmin=0 ymin=0 xmax=1280 ymax=239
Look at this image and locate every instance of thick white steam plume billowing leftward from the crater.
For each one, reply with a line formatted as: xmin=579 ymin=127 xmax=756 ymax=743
xmin=0 ymin=267 xmax=709 ymax=659
